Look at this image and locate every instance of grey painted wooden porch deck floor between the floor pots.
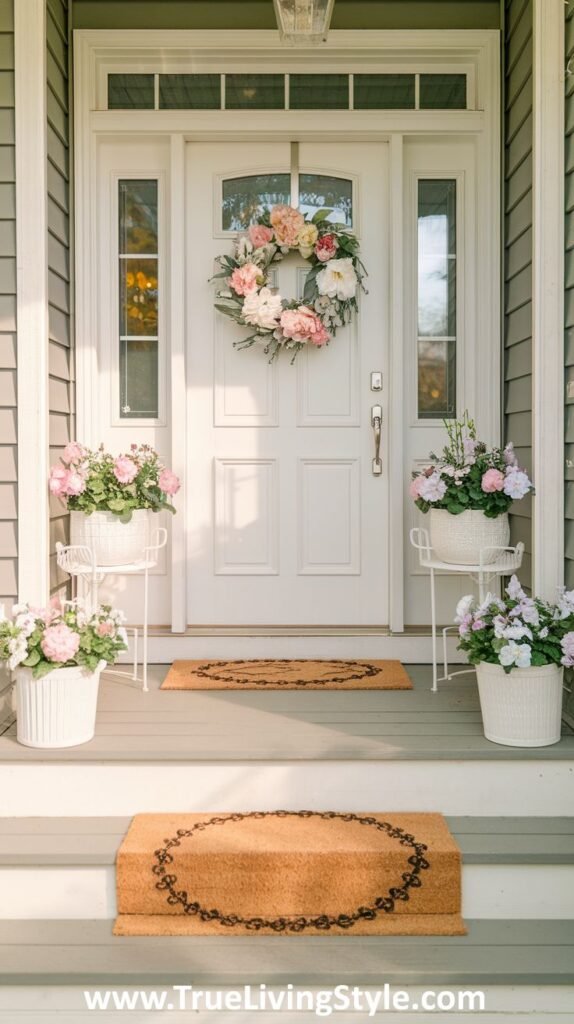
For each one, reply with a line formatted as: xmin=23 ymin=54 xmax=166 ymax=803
xmin=0 ymin=665 xmax=574 ymax=764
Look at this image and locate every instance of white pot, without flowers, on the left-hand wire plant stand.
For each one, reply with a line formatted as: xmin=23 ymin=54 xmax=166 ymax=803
xmin=71 ymin=509 xmax=153 ymax=565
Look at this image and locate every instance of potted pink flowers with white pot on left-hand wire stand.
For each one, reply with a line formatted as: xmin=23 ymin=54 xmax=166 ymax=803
xmin=49 ymin=441 xmax=180 ymax=565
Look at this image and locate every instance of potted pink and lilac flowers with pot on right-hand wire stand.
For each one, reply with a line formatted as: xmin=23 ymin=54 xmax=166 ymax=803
xmin=410 ymin=413 xmax=532 ymax=565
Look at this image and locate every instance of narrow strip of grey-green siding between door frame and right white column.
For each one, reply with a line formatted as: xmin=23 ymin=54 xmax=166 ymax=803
xmin=503 ymin=0 xmax=532 ymax=587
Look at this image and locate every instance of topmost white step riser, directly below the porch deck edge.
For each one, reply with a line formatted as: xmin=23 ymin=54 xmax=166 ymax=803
xmin=0 ymin=760 xmax=574 ymax=817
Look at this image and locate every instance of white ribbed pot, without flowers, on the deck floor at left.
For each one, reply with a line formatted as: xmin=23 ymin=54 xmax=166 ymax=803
xmin=13 ymin=662 xmax=105 ymax=748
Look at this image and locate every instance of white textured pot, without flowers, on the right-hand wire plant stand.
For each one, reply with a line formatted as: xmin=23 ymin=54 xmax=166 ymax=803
xmin=429 ymin=509 xmax=511 ymax=565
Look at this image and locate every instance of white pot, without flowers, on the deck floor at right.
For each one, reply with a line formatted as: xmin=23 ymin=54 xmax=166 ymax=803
xmin=477 ymin=662 xmax=564 ymax=746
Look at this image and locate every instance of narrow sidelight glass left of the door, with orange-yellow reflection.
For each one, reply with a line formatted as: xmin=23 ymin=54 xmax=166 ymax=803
xmin=118 ymin=179 xmax=160 ymax=419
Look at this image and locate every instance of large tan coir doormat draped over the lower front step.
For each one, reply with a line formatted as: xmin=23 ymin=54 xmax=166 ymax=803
xmin=114 ymin=811 xmax=466 ymax=937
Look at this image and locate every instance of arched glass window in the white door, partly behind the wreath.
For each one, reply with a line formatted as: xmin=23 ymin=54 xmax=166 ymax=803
xmin=221 ymin=172 xmax=353 ymax=231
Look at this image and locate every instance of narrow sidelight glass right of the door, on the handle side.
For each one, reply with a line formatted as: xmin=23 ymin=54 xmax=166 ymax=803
xmin=417 ymin=178 xmax=456 ymax=419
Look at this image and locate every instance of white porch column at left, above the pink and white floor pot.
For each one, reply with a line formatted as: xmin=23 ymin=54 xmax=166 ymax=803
xmin=14 ymin=0 xmax=49 ymax=604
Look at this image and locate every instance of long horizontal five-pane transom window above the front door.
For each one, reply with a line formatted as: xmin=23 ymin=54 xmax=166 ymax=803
xmin=107 ymin=72 xmax=471 ymax=111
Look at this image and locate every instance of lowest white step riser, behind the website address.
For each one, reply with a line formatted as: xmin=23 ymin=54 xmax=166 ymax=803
xmin=0 ymin=983 xmax=574 ymax=1024
